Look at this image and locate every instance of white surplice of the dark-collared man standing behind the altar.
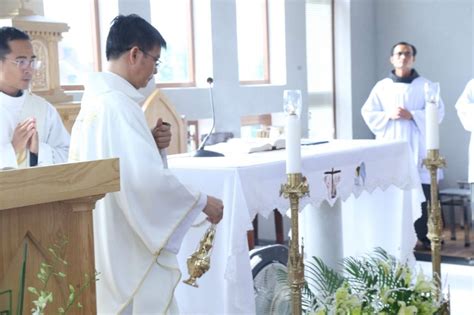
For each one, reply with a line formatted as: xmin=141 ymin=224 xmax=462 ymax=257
xmin=361 ymin=77 xmax=444 ymax=184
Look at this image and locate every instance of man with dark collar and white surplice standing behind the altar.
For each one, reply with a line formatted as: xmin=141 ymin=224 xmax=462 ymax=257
xmin=361 ymin=42 xmax=444 ymax=250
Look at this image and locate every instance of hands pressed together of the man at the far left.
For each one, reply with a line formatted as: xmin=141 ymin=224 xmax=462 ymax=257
xmin=12 ymin=118 xmax=39 ymax=154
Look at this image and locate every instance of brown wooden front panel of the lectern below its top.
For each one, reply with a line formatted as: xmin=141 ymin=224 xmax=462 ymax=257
xmin=0 ymin=198 xmax=96 ymax=314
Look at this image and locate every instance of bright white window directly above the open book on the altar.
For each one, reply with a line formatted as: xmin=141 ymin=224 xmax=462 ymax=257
xmin=236 ymin=0 xmax=269 ymax=84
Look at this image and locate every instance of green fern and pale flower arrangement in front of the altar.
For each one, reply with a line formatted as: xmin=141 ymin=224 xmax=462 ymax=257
xmin=288 ymin=248 xmax=449 ymax=315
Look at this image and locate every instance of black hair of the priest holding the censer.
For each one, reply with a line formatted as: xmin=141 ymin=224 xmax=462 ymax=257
xmin=105 ymin=14 xmax=166 ymax=60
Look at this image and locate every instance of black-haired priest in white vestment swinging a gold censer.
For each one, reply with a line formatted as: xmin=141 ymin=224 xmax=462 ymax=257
xmin=70 ymin=15 xmax=223 ymax=314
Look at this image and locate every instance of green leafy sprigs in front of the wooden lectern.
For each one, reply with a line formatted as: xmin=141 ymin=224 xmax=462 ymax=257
xmin=28 ymin=236 xmax=99 ymax=315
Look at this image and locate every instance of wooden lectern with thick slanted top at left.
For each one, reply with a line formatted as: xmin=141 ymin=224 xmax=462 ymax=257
xmin=0 ymin=159 xmax=120 ymax=314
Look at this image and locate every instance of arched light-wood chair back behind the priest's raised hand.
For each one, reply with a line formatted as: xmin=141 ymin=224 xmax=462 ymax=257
xmin=142 ymin=89 xmax=187 ymax=154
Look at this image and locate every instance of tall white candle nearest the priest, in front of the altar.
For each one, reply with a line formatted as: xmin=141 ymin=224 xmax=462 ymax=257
xmin=286 ymin=114 xmax=301 ymax=174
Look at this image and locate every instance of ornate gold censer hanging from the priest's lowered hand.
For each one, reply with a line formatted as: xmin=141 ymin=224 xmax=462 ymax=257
xmin=183 ymin=224 xmax=216 ymax=288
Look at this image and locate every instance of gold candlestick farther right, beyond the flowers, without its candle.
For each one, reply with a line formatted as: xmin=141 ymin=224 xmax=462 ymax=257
xmin=423 ymin=149 xmax=446 ymax=299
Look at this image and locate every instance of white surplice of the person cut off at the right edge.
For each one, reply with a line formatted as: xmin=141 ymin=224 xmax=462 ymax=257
xmin=456 ymin=79 xmax=474 ymax=183
